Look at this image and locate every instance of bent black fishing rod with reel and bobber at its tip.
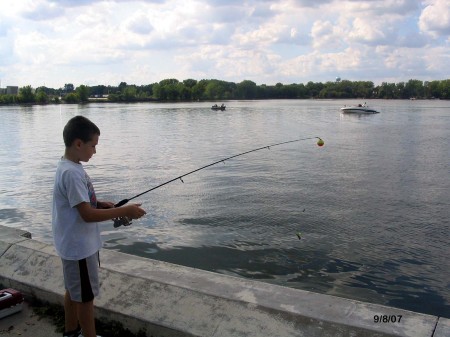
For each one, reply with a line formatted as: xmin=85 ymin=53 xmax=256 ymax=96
xmin=114 ymin=137 xmax=325 ymax=227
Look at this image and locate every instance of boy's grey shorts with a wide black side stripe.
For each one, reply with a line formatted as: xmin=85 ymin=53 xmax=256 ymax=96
xmin=61 ymin=252 xmax=99 ymax=303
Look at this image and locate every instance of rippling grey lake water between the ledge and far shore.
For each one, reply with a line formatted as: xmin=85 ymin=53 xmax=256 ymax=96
xmin=0 ymin=100 xmax=450 ymax=318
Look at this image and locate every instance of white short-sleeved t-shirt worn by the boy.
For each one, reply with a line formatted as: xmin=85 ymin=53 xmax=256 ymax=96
xmin=52 ymin=158 xmax=102 ymax=260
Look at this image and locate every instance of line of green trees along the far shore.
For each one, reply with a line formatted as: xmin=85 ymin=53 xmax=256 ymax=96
xmin=0 ymin=79 xmax=450 ymax=104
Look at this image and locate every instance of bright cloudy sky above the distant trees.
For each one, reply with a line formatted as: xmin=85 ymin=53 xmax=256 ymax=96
xmin=0 ymin=0 xmax=450 ymax=89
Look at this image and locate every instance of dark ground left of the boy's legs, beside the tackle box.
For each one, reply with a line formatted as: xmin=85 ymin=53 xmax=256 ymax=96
xmin=0 ymin=301 xmax=62 ymax=337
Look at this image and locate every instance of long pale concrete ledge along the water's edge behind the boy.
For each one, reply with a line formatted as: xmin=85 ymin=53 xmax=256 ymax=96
xmin=0 ymin=226 xmax=442 ymax=337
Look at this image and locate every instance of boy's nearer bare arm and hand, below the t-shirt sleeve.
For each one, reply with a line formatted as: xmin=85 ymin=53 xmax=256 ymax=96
xmin=75 ymin=202 xmax=146 ymax=222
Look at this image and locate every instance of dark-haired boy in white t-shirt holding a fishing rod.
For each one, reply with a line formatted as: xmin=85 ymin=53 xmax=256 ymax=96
xmin=52 ymin=116 xmax=146 ymax=337
